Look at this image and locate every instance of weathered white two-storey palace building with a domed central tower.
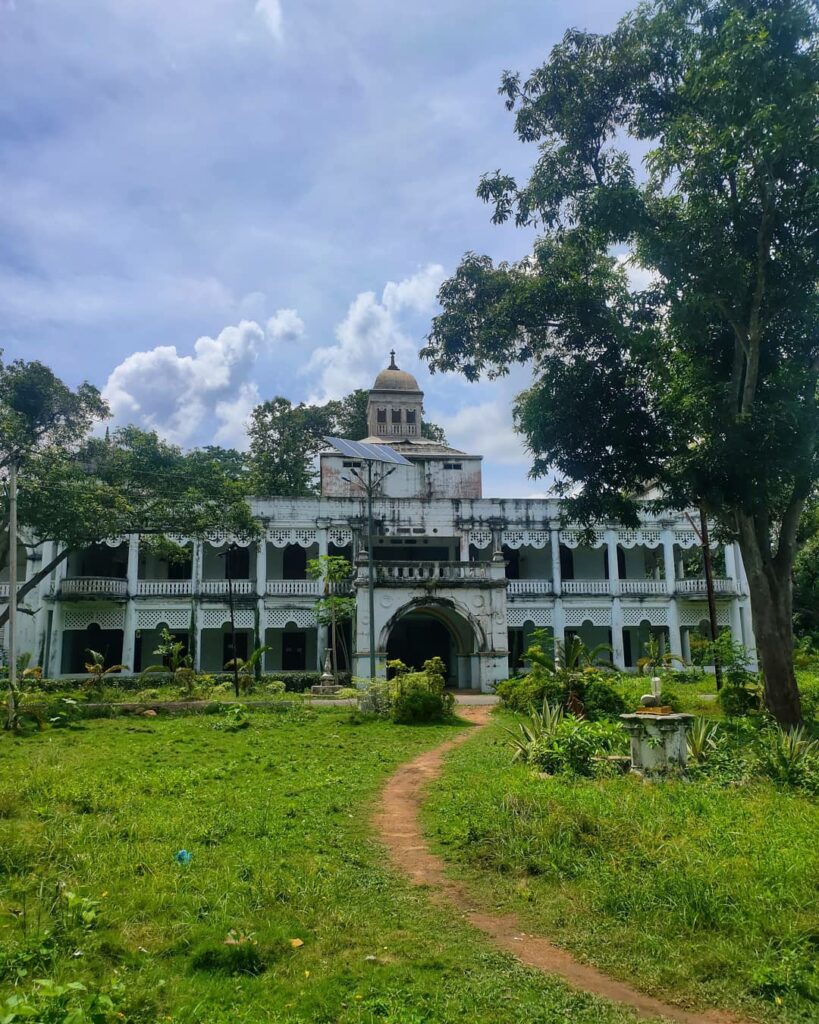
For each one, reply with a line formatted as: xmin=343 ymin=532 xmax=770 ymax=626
xmin=0 ymin=358 xmax=755 ymax=691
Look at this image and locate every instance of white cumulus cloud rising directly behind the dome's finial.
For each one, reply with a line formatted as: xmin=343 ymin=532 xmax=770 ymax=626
xmin=306 ymin=263 xmax=443 ymax=401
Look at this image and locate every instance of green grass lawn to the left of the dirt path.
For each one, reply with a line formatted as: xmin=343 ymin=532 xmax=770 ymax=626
xmin=0 ymin=705 xmax=651 ymax=1024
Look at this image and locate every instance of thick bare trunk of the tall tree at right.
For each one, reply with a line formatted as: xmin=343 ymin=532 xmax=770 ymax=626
xmin=739 ymin=529 xmax=802 ymax=726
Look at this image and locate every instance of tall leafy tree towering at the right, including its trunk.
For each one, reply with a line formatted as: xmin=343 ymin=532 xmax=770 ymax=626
xmin=425 ymin=0 xmax=819 ymax=723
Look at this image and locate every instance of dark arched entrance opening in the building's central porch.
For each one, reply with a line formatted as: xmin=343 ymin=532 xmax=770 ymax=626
xmin=382 ymin=602 xmax=480 ymax=689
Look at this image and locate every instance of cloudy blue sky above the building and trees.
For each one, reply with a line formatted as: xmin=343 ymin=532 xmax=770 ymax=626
xmin=0 ymin=0 xmax=631 ymax=496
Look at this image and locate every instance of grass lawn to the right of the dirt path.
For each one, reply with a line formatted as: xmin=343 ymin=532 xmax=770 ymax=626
xmin=425 ymin=714 xmax=819 ymax=1022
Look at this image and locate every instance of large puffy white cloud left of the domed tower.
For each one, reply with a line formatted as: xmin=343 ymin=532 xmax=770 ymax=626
xmin=103 ymin=321 xmax=271 ymax=446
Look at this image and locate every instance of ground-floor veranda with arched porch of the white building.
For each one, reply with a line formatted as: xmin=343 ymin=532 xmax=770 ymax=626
xmin=38 ymin=591 xmax=755 ymax=691
